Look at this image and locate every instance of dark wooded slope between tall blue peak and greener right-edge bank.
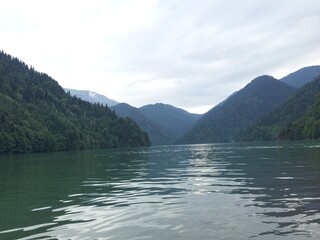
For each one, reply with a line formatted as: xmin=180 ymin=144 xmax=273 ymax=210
xmin=238 ymin=75 xmax=320 ymax=141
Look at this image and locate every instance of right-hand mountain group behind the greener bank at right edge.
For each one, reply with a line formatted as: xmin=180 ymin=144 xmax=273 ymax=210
xmin=178 ymin=66 xmax=320 ymax=143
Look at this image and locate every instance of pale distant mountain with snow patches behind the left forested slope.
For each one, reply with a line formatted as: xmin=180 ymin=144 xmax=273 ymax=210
xmin=64 ymin=88 xmax=118 ymax=107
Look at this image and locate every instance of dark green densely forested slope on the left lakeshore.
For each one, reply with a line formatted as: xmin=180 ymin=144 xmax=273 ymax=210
xmin=0 ymin=51 xmax=150 ymax=153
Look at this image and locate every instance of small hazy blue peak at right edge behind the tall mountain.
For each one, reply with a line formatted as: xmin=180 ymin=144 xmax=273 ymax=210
xmin=280 ymin=66 xmax=320 ymax=88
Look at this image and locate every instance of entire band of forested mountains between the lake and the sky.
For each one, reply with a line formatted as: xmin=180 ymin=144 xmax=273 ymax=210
xmin=0 ymin=51 xmax=320 ymax=153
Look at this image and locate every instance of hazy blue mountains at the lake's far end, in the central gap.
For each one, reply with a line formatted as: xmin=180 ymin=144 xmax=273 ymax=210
xmin=111 ymin=103 xmax=200 ymax=145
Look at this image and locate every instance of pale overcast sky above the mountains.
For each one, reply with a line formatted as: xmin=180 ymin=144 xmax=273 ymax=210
xmin=0 ymin=0 xmax=320 ymax=113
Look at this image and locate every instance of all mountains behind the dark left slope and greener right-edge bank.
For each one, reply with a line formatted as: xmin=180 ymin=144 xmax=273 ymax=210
xmin=66 ymin=66 xmax=320 ymax=145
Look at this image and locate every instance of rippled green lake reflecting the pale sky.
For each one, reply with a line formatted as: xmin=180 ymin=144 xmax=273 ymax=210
xmin=0 ymin=142 xmax=320 ymax=240
